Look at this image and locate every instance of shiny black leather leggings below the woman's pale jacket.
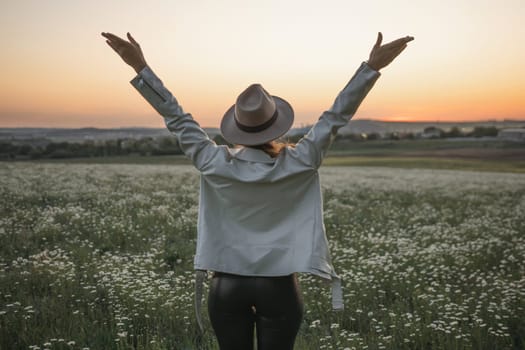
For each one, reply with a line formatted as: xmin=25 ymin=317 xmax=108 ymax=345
xmin=208 ymin=272 xmax=303 ymax=350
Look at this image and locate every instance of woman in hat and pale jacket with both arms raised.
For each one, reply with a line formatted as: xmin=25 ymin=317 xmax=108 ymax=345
xmin=102 ymin=33 xmax=413 ymax=350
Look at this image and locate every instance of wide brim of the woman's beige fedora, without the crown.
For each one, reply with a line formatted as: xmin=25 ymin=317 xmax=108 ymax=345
xmin=221 ymin=96 xmax=294 ymax=146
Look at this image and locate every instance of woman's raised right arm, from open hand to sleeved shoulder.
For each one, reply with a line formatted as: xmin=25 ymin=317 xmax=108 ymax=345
xmin=290 ymin=33 xmax=414 ymax=168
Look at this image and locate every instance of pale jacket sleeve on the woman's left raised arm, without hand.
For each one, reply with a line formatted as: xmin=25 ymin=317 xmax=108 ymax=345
xmin=131 ymin=66 xmax=220 ymax=170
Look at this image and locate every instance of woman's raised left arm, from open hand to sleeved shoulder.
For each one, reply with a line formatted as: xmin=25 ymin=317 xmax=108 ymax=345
xmin=102 ymin=33 xmax=220 ymax=170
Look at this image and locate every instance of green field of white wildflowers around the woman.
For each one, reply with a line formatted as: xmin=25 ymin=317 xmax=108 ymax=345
xmin=0 ymin=163 xmax=525 ymax=350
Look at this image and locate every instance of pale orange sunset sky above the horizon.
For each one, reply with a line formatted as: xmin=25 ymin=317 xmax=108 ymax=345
xmin=0 ymin=0 xmax=525 ymax=128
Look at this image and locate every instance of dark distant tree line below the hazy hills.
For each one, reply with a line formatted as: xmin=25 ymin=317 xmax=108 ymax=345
xmin=0 ymin=126 xmax=499 ymax=160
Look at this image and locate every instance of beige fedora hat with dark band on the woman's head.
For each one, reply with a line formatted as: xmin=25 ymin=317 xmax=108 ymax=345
xmin=221 ymin=84 xmax=294 ymax=146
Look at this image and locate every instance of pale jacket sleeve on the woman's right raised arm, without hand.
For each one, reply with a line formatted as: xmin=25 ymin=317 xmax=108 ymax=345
xmin=289 ymin=62 xmax=380 ymax=168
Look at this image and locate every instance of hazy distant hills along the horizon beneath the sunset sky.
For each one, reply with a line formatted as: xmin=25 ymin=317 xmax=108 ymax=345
xmin=0 ymin=119 xmax=525 ymax=142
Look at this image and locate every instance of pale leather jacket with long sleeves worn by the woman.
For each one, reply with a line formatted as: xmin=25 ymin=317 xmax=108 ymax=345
xmin=131 ymin=63 xmax=379 ymax=326
